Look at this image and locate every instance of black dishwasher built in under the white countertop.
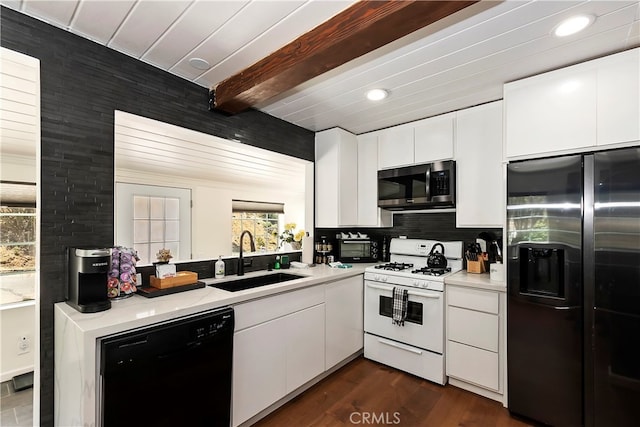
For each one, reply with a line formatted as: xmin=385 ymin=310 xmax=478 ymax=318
xmin=98 ymin=307 xmax=234 ymax=427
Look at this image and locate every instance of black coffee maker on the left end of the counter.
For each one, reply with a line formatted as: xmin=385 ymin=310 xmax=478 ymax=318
xmin=67 ymin=248 xmax=111 ymax=313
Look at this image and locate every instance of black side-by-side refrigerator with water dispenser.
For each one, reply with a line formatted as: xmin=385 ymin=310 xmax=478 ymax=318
xmin=506 ymin=148 xmax=640 ymax=427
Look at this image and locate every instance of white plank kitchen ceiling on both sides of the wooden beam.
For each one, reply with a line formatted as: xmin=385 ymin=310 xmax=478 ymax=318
xmin=0 ymin=0 xmax=640 ymax=134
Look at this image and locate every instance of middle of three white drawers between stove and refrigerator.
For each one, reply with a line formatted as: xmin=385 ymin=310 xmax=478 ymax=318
xmin=447 ymin=307 xmax=499 ymax=352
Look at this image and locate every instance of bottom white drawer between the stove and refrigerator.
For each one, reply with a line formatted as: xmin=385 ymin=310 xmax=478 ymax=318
xmin=447 ymin=341 xmax=500 ymax=391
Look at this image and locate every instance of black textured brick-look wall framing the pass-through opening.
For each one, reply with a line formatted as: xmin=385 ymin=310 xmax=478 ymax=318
xmin=0 ymin=7 xmax=314 ymax=426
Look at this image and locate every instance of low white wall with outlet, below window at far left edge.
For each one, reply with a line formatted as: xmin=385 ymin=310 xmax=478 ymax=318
xmin=0 ymin=301 xmax=37 ymax=381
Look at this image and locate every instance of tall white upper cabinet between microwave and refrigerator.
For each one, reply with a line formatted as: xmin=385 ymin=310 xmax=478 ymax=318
xmin=455 ymin=101 xmax=504 ymax=228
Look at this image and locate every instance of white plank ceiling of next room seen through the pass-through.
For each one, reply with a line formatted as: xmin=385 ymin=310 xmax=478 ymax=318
xmin=114 ymin=111 xmax=309 ymax=194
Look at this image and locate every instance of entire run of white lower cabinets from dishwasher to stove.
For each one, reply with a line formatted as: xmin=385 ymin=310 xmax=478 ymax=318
xmin=232 ymin=275 xmax=364 ymax=426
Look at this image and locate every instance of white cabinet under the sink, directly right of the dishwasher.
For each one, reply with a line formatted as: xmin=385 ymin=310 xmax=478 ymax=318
xmin=233 ymin=286 xmax=325 ymax=426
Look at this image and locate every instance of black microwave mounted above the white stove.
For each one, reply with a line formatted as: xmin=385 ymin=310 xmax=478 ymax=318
xmin=378 ymin=160 xmax=456 ymax=210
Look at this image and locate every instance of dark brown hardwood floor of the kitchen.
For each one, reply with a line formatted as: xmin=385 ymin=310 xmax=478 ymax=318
xmin=255 ymin=357 xmax=529 ymax=427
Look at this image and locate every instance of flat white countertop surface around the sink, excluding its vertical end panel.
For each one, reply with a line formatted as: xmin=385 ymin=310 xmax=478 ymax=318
xmin=56 ymin=264 xmax=373 ymax=337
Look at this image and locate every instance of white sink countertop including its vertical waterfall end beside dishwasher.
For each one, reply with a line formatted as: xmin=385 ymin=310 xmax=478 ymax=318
xmin=54 ymin=264 xmax=372 ymax=426
